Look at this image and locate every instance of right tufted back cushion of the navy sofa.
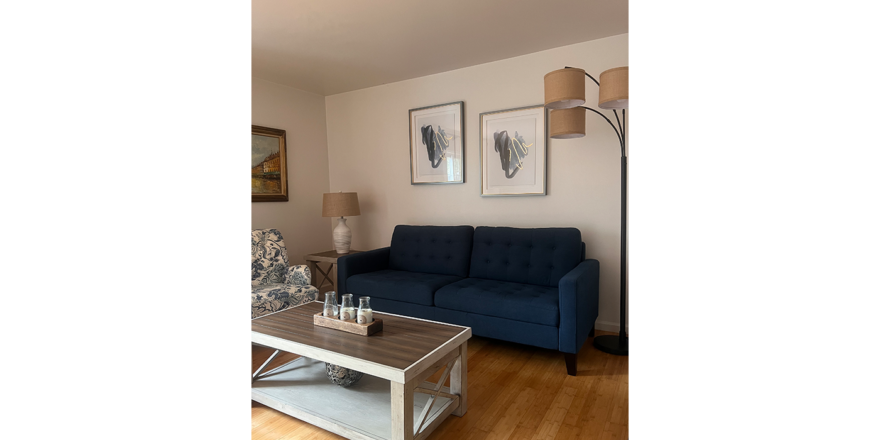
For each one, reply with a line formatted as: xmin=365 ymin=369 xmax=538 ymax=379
xmin=469 ymin=226 xmax=582 ymax=287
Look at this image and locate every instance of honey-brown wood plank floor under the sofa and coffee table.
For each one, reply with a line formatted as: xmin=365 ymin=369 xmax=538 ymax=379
xmin=251 ymin=330 xmax=629 ymax=440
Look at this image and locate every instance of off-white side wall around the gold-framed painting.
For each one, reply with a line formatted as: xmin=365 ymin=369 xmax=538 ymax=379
xmin=251 ymin=77 xmax=333 ymax=264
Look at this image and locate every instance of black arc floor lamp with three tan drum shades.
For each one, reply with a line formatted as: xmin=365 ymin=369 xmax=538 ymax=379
xmin=544 ymin=66 xmax=629 ymax=356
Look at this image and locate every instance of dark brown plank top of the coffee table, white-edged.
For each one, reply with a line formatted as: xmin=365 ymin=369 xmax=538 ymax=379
xmin=251 ymin=301 xmax=471 ymax=370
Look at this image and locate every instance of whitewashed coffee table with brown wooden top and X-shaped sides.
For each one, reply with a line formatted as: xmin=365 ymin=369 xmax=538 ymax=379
xmin=251 ymin=301 xmax=471 ymax=440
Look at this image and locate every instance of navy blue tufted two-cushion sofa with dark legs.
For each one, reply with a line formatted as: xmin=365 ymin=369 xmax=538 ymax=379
xmin=337 ymin=225 xmax=599 ymax=376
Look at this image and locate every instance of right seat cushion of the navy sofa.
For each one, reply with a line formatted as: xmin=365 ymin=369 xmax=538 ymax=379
xmin=434 ymin=278 xmax=559 ymax=326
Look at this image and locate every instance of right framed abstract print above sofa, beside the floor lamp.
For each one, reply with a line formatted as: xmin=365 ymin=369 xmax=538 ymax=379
xmin=480 ymin=105 xmax=549 ymax=197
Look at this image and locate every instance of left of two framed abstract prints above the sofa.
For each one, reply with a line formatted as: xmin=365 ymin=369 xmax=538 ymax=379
xmin=409 ymin=101 xmax=465 ymax=185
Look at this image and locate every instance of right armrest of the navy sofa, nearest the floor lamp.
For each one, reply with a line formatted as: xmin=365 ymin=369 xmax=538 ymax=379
xmin=559 ymin=260 xmax=599 ymax=353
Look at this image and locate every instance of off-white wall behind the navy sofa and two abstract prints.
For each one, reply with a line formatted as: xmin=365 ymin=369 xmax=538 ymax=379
xmin=325 ymin=34 xmax=629 ymax=331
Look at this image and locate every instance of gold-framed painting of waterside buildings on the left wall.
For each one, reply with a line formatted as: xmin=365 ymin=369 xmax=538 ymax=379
xmin=251 ymin=125 xmax=287 ymax=202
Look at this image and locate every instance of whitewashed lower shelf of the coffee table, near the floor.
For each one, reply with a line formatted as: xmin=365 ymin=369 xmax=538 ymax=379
xmin=251 ymin=357 xmax=457 ymax=440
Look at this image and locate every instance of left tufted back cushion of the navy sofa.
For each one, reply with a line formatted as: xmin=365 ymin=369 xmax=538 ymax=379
xmin=388 ymin=225 xmax=474 ymax=278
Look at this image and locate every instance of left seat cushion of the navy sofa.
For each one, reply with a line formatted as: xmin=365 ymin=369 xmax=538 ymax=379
xmin=346 ymin=269 xmax=462 ymax=306
